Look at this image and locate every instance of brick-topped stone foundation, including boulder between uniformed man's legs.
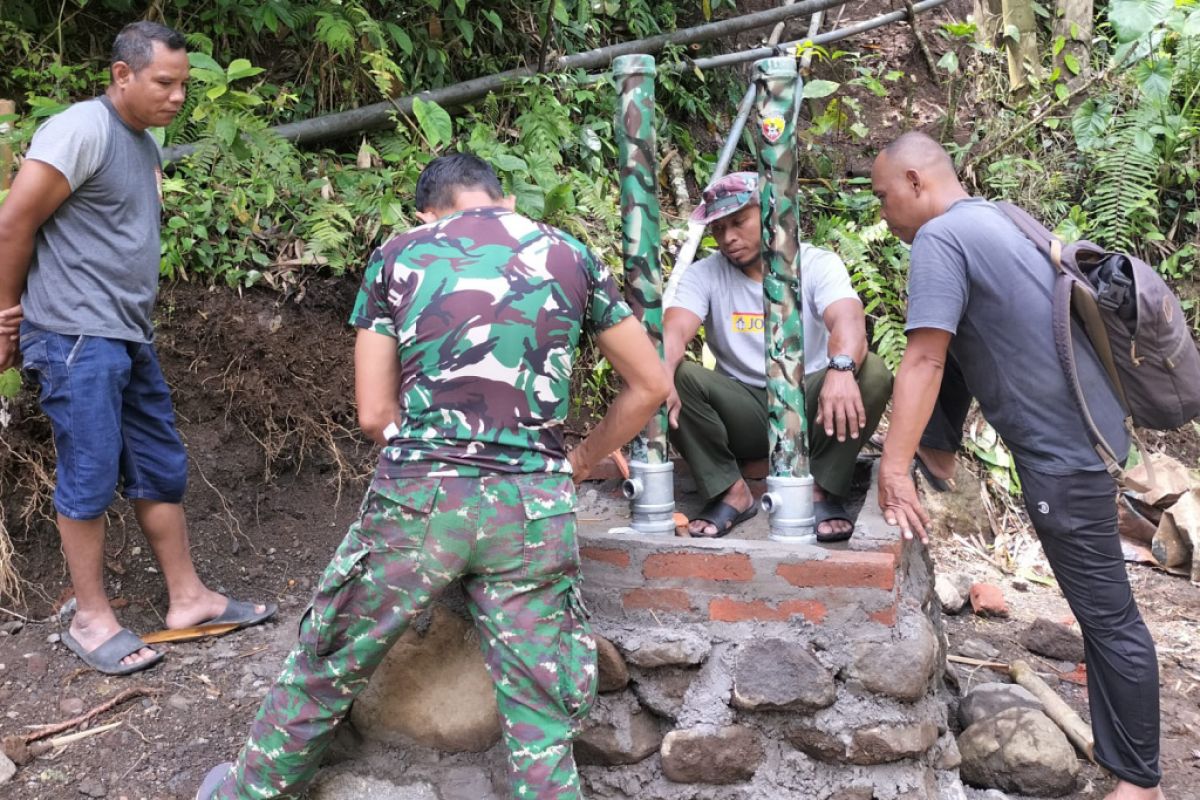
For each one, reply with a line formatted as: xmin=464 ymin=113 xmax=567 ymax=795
xmin=314 ymin=462 xmax=964 ymax=800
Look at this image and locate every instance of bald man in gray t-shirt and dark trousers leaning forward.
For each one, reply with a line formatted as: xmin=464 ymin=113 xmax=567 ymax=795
xmin=871 ymin=133 xmax=1163 ymax=800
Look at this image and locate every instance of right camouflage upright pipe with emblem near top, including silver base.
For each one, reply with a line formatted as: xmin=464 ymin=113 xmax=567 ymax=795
xmin=754 ymin=56 xmax=814 ymax=540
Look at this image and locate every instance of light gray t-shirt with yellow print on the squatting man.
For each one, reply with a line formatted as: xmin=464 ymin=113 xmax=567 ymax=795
xmin=670 ymin=242 xmax=858 ymax=387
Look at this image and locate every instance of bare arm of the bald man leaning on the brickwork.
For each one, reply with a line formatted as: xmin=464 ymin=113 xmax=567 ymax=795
xmin=880 ymin=327 xmax=952 ymax=542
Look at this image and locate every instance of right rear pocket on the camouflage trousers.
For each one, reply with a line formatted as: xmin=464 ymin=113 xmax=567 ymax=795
xmin=520 ymin=474 xmax=580 ymax=577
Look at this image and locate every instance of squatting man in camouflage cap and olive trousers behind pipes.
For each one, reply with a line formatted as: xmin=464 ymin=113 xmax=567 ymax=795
xmin=662 ymin=173 xmax=892 ymax=542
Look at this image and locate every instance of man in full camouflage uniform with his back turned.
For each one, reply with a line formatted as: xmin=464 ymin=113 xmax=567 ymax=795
xmin=197 ymin=154 xmax=670 ymax=800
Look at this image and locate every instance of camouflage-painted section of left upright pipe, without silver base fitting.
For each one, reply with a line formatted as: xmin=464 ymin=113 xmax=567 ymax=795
xmin=612 ymin=55 xmax=667 ymax=464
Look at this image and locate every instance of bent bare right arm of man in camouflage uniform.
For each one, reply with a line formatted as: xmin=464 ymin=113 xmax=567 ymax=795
xmin=570 ymin=317 xmax=671 ymax=483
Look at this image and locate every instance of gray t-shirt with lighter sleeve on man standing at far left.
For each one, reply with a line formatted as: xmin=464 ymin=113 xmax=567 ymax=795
xmin=22 ymin=97 xmax=162 ymax=342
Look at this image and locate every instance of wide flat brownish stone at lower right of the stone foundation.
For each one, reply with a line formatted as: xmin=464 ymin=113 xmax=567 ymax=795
xmin=786 ymin=722 xmax=937 ymax=766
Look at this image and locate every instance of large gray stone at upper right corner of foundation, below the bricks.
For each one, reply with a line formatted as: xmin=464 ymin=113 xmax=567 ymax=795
xmin=846 ymin=614 xmax=937 ymax=703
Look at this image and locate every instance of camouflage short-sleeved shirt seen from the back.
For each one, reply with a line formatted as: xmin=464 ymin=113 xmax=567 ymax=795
xmin=350 ymin=207 xmax=631 ymax=477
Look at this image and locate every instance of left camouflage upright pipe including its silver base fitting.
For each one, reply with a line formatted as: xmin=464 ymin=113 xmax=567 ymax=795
xmin=612 ymin=55 xmax=674 ymax=535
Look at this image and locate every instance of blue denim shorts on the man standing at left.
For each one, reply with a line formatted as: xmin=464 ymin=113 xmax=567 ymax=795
xmin=20 ymin=321 xmax=187 ymax=519
